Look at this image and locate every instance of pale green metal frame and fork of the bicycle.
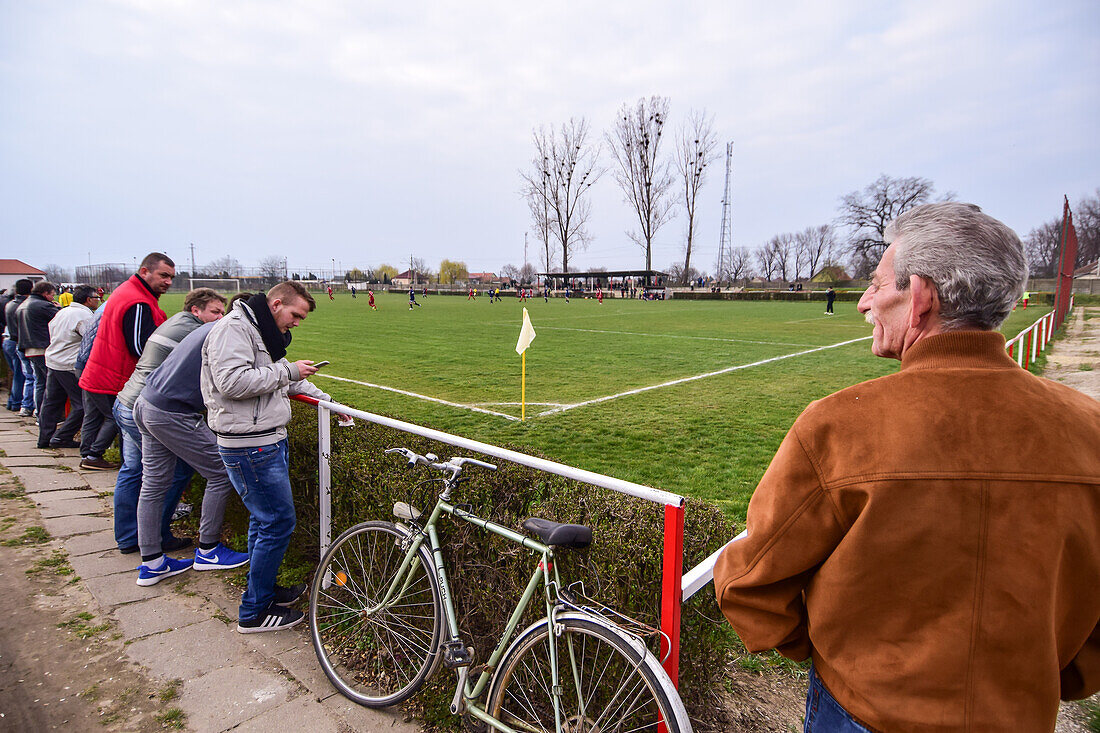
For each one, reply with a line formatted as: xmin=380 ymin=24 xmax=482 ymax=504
xmin=378 ymin=482 xmax=561 ymax=733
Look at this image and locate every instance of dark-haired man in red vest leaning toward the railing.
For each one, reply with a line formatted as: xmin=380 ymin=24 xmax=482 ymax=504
xmin=79 ymin=252 xmax=176 ymax=549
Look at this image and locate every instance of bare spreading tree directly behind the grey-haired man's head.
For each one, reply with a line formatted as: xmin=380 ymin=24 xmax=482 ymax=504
xmin=837 ymin=175 xmax=932 ymax=276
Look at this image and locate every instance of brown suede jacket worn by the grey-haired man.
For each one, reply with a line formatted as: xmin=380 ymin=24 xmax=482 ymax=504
xmin=714 ymin=331 xmax=1100 ymax=731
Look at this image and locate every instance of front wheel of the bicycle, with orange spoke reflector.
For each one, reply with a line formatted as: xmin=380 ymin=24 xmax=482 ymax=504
xmin=309 ymin=522 xmax=442 ymax=708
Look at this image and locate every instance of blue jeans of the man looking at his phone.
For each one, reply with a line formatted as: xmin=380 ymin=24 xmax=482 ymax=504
xmin=218 ymin=439 xmax=295 ymax=621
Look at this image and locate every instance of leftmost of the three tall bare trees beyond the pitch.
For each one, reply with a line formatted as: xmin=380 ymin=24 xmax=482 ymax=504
xmin=520 ymin=117 xmax=604 ymax=272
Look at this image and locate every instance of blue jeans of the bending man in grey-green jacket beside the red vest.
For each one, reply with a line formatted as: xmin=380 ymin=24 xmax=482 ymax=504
xmin=111 ymin=400 xmax=195 ymax=549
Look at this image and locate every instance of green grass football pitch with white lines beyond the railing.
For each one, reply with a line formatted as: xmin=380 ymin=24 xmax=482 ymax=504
xmin=163 ymin=293 xmax=1047 ymax=522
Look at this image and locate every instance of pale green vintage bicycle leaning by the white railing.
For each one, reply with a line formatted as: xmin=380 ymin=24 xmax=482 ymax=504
xmin=309 ymin=448 xmax=692 ymax=733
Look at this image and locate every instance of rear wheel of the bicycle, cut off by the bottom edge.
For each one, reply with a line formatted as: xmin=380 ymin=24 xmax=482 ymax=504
xmin=488 ymin=614 xmax=691 ymax=733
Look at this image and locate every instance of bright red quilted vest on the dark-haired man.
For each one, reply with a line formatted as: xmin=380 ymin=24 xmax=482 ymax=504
xmin=80 ymin=275 xmax=168 ymax=394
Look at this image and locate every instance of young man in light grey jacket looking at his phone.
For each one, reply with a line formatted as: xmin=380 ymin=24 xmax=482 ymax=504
xmin=201 ymin=281 xmax=330 ymax=634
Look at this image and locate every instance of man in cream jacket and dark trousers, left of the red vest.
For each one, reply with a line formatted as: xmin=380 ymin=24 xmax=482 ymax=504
xmin=39 ymin=285 xmax=99 ymax=448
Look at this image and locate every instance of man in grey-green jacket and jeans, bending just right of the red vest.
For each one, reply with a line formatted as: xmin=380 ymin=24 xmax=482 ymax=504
xmin=111 ymin=287 xmax=226 ymax=555
